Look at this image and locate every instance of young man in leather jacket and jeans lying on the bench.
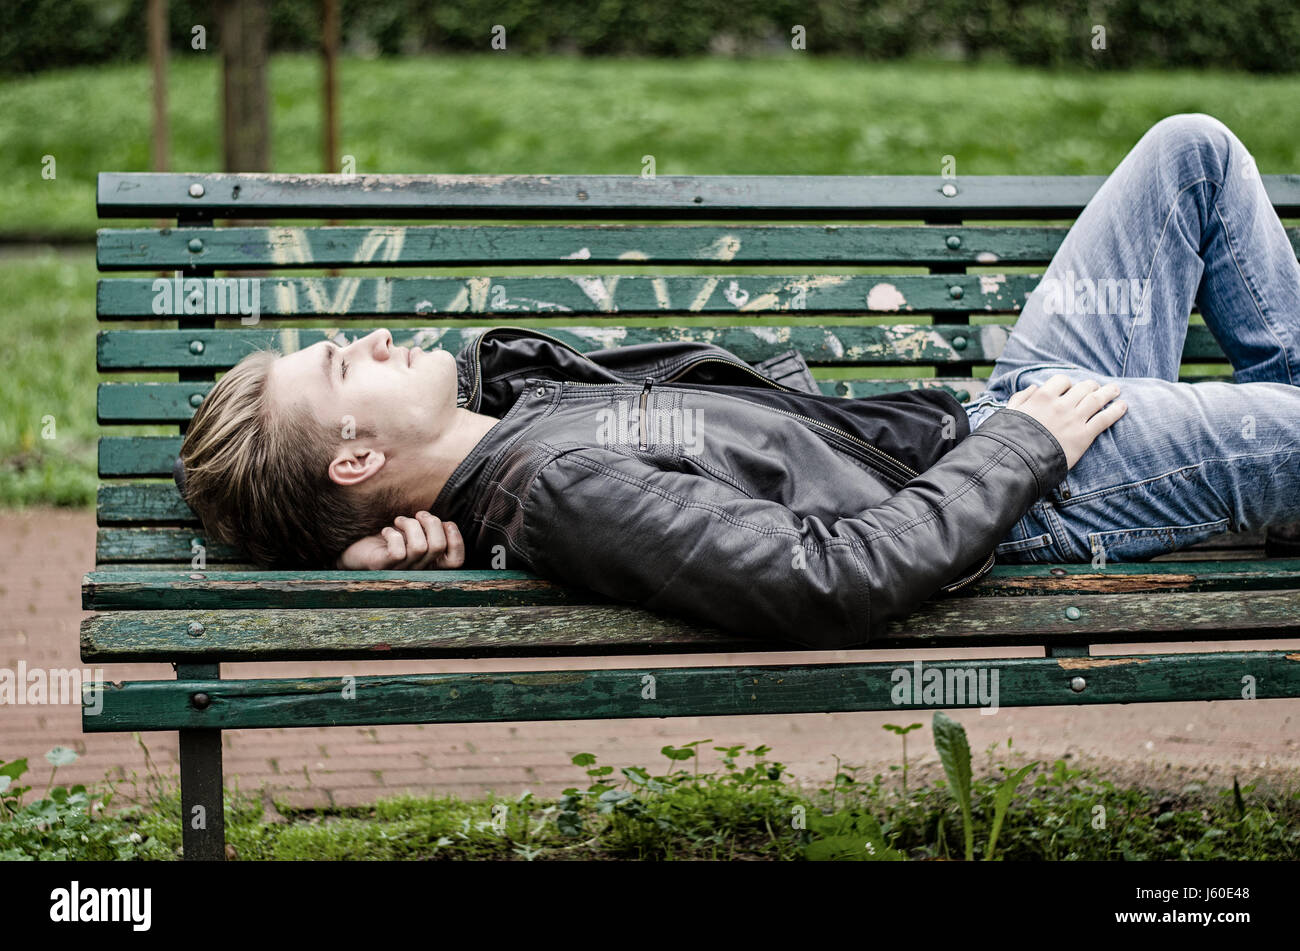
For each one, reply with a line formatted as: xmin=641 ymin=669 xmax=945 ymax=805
xmin=178 ymin=114 xmax=1300 ymax=648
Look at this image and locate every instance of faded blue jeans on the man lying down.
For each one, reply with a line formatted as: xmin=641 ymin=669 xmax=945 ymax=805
xmin=965 ymin=114 xmax=1300 ymax=564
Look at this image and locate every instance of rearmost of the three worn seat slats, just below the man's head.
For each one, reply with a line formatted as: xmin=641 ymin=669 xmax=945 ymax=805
xmin=82 ymin=559 xmax=1300 ymax=613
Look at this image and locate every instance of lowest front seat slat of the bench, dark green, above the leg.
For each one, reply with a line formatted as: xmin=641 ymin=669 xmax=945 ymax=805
xmin=82 ymin=651 xmax=1300 ymax=733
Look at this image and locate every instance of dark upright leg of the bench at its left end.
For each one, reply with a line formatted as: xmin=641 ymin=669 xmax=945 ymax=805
xmin=176 ymin=664 xmax=226 ymax=861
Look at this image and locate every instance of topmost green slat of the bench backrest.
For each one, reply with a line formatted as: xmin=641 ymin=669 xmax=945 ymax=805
xmin=96 ymin=171 xmax=1300 ymax=220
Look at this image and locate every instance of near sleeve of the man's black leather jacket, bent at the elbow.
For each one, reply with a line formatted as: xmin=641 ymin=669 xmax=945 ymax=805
xmin=520 ymin=409 xmax=1067 ymax=648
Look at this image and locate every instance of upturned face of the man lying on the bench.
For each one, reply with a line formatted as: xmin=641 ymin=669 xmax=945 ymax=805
xmin=268 ymin=329 xmax=456 ymax=485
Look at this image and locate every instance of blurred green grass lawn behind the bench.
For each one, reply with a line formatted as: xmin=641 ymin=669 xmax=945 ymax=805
xmin=0 ymin=53 xmax=1300 ymax=505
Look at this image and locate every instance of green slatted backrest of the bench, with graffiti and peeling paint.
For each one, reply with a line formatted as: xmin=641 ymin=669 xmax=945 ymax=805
xmin=96 ymin=173 xmax=1300 ymax=568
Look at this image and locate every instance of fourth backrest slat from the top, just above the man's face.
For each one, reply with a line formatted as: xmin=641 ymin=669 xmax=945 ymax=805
xmin=96 ymin=322 xmax=1226 ymax=370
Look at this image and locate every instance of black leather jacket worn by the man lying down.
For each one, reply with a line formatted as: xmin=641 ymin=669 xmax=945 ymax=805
xmin=432 ymin=327 xmax=1067 ymax=648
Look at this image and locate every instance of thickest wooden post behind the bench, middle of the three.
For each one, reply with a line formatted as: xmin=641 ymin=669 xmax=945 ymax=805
xmin=217 ymin=0 xmax=270 ymax=171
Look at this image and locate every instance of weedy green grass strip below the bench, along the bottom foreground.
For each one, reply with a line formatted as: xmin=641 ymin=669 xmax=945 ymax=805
xmin=0 ymin=739 xmax=1300 ymax=861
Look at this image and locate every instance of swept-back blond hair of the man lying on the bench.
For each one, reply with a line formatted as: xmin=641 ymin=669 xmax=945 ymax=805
xmin=181 ymin=349 xmax=402 ymax=568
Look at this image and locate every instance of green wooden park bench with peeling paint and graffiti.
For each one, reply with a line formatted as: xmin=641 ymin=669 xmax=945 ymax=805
xmin=81 ymin=173 xmax=1300 ymax=859
